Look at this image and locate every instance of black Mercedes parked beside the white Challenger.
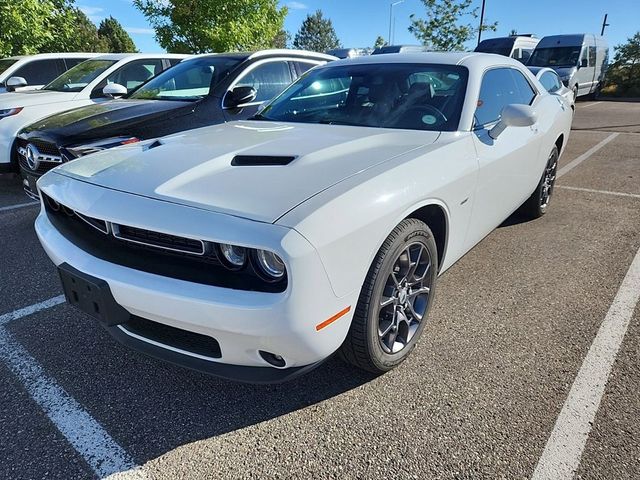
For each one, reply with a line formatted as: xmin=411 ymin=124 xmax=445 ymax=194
xmin=14 ymin=50 xmax=335 ymax=197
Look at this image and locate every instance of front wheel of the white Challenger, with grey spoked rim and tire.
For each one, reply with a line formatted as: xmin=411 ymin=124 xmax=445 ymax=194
xmin=340 ymin=218 xmax=438 ymax=373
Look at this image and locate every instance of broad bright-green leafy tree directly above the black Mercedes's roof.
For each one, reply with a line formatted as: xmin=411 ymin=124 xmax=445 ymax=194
xmin=133 ymin=0 xmax=287 ymax=53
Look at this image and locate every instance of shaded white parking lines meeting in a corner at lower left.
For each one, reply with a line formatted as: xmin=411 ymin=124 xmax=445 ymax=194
xmin=0 ymin=295 xmax=144 ymax=480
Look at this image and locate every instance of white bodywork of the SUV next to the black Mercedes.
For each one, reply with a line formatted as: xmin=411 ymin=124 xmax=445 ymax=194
xmin=0 ymin=53 xmax=186 ymax=170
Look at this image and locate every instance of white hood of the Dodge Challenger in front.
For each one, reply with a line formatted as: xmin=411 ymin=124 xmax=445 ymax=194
xmin=53 ymin=121 xmax=439 ymax=223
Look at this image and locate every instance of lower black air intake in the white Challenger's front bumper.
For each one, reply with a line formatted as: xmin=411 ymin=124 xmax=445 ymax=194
xmin=122 ymin=315 xmax=222 ymax=358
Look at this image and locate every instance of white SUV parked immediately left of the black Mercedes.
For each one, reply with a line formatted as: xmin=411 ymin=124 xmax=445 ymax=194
xmin=0 ymin=53 xmax=186 ymax=172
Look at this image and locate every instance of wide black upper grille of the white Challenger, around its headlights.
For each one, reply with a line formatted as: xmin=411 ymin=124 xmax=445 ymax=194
xmin=42 ymin=194 xmax=287 ymax=293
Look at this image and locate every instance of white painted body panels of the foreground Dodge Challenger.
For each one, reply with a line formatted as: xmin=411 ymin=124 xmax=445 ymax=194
xmin=36 ymin=53 xmax=572 ymax=382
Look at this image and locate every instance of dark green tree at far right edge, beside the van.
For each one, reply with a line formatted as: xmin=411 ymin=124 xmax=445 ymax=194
xmin=603 ymin=32 xmax=640 ymax=97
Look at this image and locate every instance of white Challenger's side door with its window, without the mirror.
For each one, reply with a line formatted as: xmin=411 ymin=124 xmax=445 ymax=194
xmin=469 ymin=67 xmax=540 ymax=243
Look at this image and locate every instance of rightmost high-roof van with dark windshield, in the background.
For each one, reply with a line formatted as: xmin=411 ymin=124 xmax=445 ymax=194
xmin=527 ymin=33 xmax=609 ymax=98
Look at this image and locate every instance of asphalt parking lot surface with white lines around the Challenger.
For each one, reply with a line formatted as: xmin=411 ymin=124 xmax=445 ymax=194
xmin=0 ymin=102 xmax=640 ymax=479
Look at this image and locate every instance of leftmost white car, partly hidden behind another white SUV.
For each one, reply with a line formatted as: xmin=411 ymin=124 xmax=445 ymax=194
xmin=0 ymin=53 xmax=100 ymax=93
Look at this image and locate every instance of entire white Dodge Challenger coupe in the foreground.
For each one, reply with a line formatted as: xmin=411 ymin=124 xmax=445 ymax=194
xmin=36 ymin=53 xmax=572 ymax=382
